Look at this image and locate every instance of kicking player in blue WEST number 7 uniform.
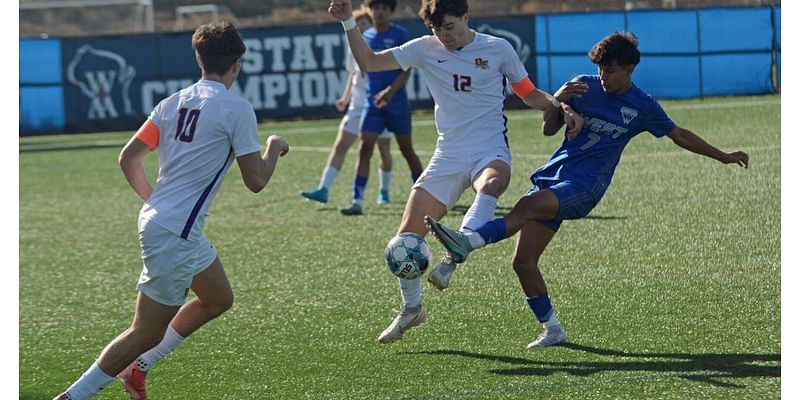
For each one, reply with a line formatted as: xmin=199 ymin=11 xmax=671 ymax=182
xmin=425 ymin=32 xmax=748 ymax=348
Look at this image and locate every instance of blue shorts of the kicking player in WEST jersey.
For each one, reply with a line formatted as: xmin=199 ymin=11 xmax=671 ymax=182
xmin=525 ymin=180 xmax=600 ymax=232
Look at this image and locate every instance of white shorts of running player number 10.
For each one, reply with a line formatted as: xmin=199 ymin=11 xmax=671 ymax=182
xmin=136 ymin=219 xmax=217 ymax=306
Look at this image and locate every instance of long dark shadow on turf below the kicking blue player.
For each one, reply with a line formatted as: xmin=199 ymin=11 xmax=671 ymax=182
xmin=409 ymin=343 xmax=781 ymax=388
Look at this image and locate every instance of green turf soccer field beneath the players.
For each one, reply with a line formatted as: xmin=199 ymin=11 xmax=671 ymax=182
xmin=19 ymin=96 xmax=781 ymax=400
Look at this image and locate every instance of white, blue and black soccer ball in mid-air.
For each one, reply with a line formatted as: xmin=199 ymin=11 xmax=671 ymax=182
xmin=384 ymin=232 xmax=431 ymax=279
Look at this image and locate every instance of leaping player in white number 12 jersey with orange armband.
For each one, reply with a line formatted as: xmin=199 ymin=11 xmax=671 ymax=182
xmin=328 ymin=0 xmax=583 ymax=343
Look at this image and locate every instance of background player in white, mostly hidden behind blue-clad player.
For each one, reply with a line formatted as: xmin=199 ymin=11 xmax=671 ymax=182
xmin=300 ymin=6 xmax=392 ymax=204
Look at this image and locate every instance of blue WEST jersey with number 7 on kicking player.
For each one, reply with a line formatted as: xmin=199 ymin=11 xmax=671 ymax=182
xmin=531 ymin=75 xmax=676 ymax=201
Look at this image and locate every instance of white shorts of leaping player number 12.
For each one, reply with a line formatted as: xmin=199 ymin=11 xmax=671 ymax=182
xmin=413 ymin=146 xmax=511 ymax=210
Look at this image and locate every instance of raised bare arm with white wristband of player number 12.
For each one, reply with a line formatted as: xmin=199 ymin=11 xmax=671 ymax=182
xmin=328 ymin=0 xmax=401 ymax=72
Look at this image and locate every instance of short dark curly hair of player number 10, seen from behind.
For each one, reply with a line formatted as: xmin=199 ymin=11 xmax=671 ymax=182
xmin=192 ymin=21 xmax=245 ymax=75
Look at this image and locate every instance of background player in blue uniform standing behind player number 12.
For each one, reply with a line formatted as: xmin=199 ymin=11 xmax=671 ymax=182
xmin=341 ymin=0 xmax=422 ymax=215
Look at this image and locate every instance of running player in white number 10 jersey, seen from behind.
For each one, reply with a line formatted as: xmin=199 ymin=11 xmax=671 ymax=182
xmin=50 ymin=22 xmax=289 ymax=400
